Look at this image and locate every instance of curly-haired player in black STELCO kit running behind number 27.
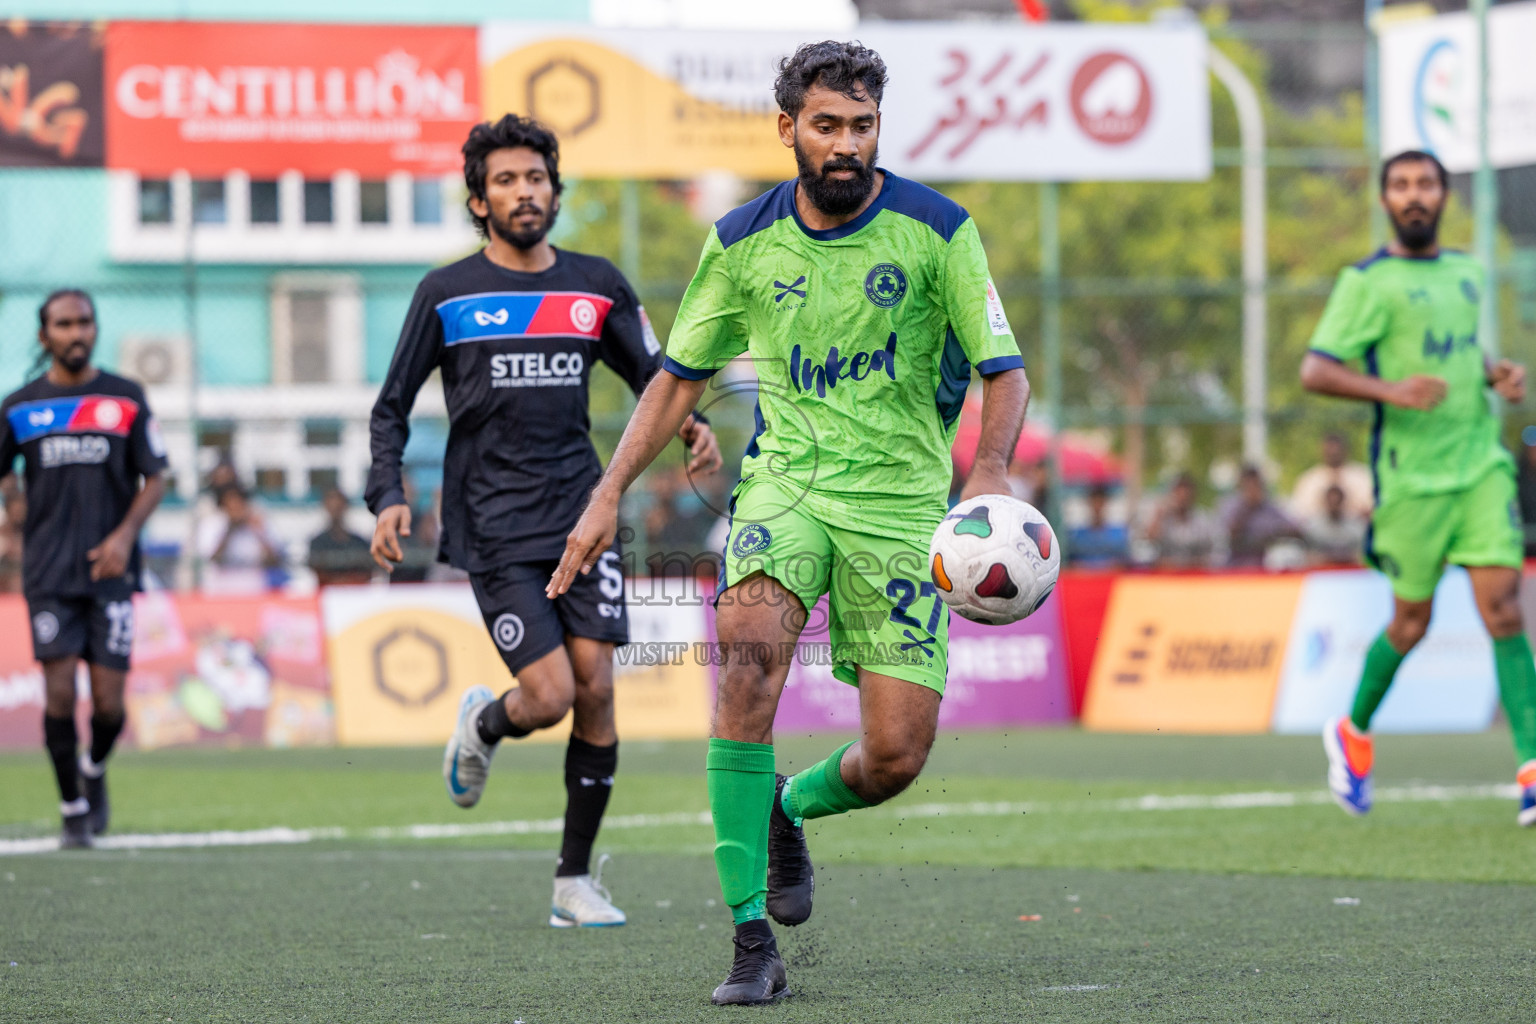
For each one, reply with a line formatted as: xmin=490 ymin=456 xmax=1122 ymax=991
xmin=367 ymin=115 xmax=720 ymax=927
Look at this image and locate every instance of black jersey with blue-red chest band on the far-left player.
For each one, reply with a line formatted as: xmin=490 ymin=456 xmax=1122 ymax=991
xmin=0 ymin=372 xmax=166 ymax=597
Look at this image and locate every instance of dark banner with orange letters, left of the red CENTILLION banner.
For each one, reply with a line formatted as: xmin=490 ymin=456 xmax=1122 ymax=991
xmin=0 ymin=20 xmax=106 ymax=167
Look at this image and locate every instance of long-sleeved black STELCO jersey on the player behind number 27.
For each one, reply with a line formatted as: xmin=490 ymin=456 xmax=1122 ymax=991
xmin=367 ymin=249 xmax=662 ymax=573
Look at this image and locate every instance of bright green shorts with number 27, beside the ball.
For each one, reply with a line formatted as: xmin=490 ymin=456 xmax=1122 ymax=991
xmin=716 ymin=477 xmax=949 ymax=694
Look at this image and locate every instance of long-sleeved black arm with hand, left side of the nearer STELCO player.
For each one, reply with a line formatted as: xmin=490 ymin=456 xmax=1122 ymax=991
xmin=364 ymin=281 xmax=442 ymax=571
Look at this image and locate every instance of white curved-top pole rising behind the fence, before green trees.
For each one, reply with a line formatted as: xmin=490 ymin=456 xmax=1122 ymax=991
xmin=1206 ymin=46 xmax=1269 ymax=465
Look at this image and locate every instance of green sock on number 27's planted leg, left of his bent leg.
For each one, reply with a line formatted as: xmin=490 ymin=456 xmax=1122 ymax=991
xmin=705 ymin=738 xmax=774 ymax=924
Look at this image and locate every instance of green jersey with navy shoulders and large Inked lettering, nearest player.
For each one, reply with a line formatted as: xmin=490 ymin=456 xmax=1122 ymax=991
xmin=665 ymin=172 xmax=1025 ymax=545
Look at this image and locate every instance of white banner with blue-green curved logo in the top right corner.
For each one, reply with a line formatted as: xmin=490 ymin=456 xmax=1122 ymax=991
xmin=1379 ymin=3 xmax=1536 ymax=170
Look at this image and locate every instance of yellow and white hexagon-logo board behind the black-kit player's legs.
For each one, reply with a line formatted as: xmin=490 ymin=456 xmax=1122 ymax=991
xmin=321 ymin=580 xmax=710 ymax=746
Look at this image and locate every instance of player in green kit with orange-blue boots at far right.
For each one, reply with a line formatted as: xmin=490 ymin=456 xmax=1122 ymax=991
xmin=1301 ymin=150 xmax=1536 ymax=824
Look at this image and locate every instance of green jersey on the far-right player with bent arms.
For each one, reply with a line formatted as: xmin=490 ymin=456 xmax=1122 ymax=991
xmin=1312 ymin=249 xmax=1514 ymax=502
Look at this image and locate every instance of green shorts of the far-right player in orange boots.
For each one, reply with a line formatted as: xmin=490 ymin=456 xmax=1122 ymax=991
xmin=1366 ymin=467 xmax=1525 ymax=602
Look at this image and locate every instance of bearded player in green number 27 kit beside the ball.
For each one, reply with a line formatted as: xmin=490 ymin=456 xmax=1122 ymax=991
xmin=550 ymin=41 xmax=1029 ymax=1004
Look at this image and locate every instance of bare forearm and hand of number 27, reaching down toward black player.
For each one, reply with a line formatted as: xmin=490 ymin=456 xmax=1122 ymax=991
xmin=545 ymin=370 xmax=705 ymax=599
